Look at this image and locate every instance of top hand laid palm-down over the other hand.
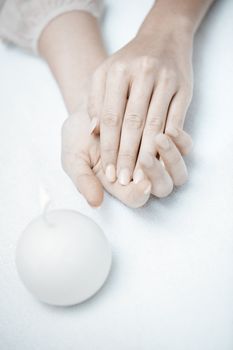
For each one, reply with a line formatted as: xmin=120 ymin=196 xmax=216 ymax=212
xmin=88 ymin=29 xmax=192 ymax=185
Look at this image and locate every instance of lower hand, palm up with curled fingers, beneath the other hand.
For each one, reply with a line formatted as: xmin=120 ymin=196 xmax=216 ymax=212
xmin=61 ymin=95 xmax=193 ymax=208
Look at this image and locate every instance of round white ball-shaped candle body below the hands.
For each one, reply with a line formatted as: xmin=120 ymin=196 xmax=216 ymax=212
xmin=16 ymin=210 xmax=112 ymax=306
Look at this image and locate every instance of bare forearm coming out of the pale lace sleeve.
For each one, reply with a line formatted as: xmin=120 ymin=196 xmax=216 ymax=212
xmin=39 ymin=11 xmax=106 ymax=113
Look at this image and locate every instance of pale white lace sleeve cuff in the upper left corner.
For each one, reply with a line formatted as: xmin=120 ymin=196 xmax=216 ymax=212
xmin=0 ymin=0 xmax=102 ymax=53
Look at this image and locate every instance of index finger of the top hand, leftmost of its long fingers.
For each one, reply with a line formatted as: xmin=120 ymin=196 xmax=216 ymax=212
xmin=100 ymin=64 xmax=129 ymax=182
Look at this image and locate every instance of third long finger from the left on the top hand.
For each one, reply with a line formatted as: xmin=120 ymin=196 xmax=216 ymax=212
xmin=135 ymin=82 xmax=175 ymax=177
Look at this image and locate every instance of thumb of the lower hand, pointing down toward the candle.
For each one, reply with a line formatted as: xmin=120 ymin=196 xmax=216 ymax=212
xmin=62 ymin=153 xmax=104 ymax=207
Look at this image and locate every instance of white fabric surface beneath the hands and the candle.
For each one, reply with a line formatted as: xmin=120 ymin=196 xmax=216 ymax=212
xmin=0 ymin=0 xmax=233 ymax=350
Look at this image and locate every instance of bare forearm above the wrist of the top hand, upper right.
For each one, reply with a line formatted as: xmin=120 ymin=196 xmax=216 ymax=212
xmin=139 ymin=0 xmax=214 ymax=37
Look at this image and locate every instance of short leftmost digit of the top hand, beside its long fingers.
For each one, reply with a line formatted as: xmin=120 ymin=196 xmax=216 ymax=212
xmin=88 ymin=67 xmax=106 ymax=135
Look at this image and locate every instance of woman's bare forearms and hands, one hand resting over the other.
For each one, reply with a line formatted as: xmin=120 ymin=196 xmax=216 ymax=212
xmin=39 ymin=0 xmax=212 ymax=207
